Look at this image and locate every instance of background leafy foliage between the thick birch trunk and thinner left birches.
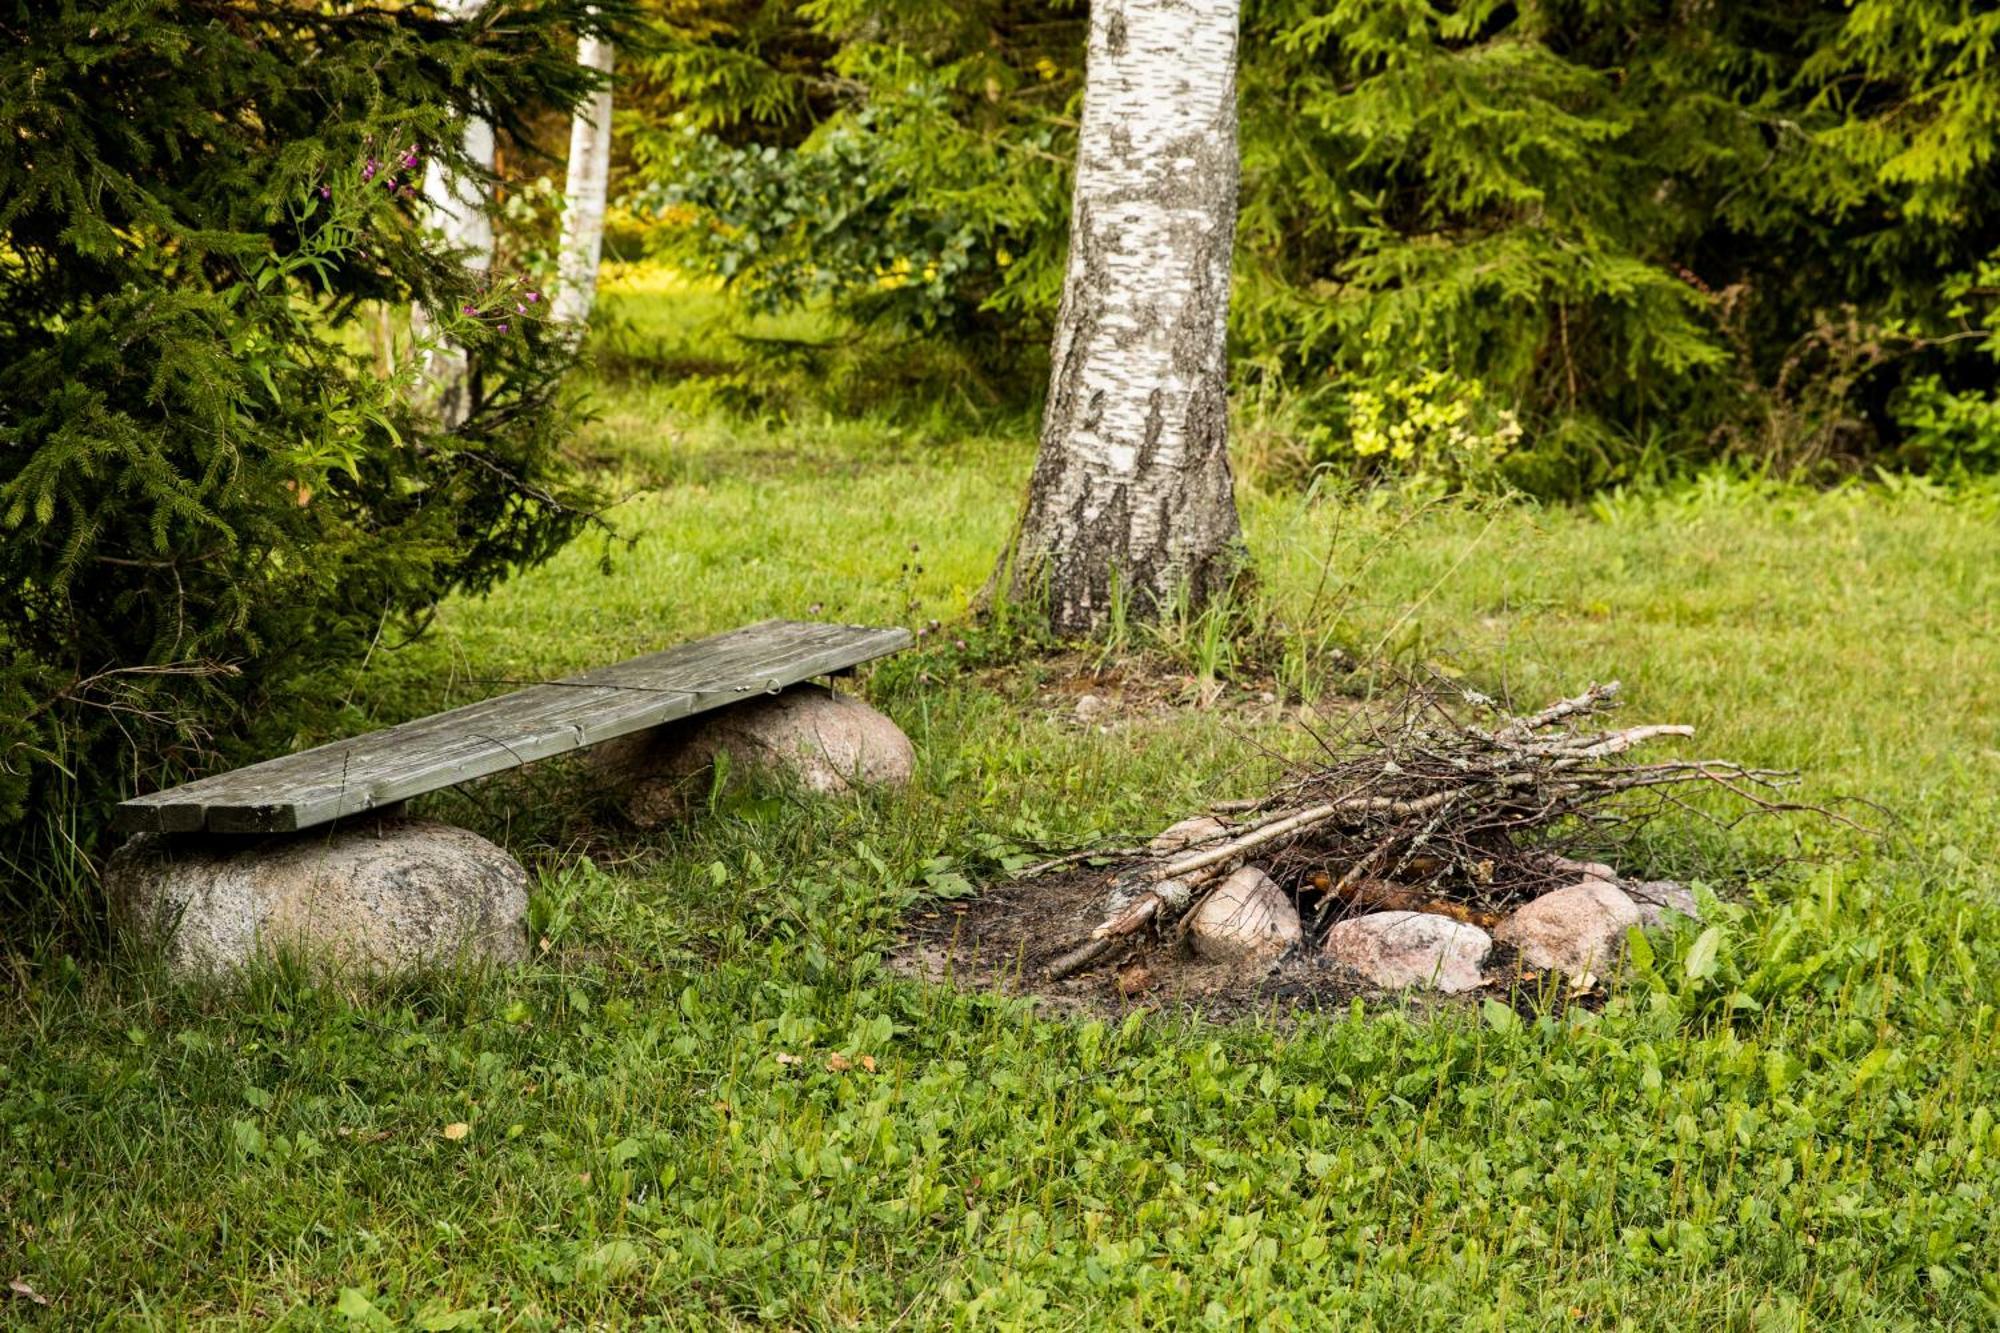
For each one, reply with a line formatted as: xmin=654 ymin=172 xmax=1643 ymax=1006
xmin=634 ymin=0 xmax=1082 ymax=366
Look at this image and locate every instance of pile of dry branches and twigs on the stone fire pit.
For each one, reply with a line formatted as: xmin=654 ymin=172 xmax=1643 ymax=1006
xmin=1036 ymin=681 xmax=1804 ymax=979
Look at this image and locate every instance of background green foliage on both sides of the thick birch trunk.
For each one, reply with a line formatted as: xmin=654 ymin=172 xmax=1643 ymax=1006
xmin=640 ymin=0 xmax=2000 ymax=492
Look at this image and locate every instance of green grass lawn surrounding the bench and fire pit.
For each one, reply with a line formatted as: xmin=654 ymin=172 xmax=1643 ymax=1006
xmin=0 ymin=274 xmax=2000 ymax=1329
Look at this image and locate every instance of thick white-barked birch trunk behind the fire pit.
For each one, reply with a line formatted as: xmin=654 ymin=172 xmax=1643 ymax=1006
xmin=998 ymin=0 xmax=1244 ymax=632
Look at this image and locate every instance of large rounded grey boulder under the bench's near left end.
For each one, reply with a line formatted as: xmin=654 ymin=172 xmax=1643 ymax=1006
xmin=104 ymin=819 xmax=528 ymax=977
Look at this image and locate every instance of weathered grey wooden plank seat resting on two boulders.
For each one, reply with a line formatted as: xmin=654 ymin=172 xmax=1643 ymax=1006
xmin=114 ymin=620 xmax=910 ymax=833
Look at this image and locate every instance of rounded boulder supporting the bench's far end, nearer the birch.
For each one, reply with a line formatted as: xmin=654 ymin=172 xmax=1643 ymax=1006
xmin=592 ymin=685 xmax=916 ymax=829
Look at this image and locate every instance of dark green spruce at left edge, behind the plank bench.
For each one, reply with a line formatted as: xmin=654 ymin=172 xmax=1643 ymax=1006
xmin=0 ymin=0 xmax=620 ymax=896
